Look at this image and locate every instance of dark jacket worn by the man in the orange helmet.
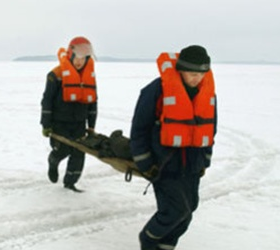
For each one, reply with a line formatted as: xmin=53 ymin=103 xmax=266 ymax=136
xmin=41 ymin=71 xmax=97 ymax=128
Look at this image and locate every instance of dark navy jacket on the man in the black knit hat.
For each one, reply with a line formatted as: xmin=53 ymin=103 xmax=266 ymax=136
xmin=130 ymin=78 xmax=217 ymax=177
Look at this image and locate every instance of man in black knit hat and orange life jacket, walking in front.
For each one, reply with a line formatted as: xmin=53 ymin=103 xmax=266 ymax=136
xmin=130 ymin=45 xmax=217 ymax=250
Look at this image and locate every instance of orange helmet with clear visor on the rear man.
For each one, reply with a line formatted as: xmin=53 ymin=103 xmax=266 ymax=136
xmin=67 ymin=36 xmax=93 ymax=59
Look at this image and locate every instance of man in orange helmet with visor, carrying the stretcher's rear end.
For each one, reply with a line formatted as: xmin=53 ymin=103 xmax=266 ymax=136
xmin=41 ymin=37 xmax=97 ymax=191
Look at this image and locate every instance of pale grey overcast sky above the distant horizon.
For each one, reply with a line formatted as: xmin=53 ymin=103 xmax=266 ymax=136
xmin=0 ymin=0 xmax=280 ymax=62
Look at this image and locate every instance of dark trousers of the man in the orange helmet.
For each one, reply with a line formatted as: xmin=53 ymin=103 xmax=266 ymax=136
xmin=49 ymin=122 xmax=85 ymax=185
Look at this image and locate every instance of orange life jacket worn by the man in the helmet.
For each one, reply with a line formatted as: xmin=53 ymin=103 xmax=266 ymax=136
xmin=58 ymin=48 xmax=97 ymax=103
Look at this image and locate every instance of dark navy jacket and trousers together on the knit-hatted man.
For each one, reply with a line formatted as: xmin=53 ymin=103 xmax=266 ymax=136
xmin=130 ymin=78 xmax=217 ymax=250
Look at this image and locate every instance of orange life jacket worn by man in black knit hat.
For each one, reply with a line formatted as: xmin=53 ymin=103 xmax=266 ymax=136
xmin=157 ymin=53 xmax=215 ymax=147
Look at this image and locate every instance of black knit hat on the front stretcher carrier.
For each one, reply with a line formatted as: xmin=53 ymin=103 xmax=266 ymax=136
xmin=176 ymin=45 xmax=210 ymax=72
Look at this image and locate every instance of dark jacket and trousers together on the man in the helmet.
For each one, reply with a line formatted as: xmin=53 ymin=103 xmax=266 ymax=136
xmin=40 ymin=71 xmax=97 ymax=186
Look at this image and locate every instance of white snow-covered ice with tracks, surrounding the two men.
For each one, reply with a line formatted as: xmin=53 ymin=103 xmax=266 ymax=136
xmin=0 ymin=62 xmax=280 ymax=250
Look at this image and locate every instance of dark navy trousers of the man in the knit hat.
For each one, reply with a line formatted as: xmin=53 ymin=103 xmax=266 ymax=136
xmin=139 ymin=173 xmax=200 ymax=249
